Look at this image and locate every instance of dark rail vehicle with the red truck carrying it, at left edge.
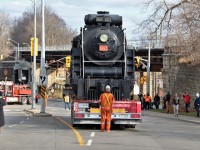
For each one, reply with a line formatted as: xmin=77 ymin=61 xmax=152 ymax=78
xmin=0 ymin=60 xmax=32 ymax=104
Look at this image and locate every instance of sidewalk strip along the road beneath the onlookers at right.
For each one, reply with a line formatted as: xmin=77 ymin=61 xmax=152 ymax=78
xmin=142 ymin=110 xmax=200 ymax=124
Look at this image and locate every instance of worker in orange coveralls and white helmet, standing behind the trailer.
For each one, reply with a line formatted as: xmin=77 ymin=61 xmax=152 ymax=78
xmin=99 ymin=85 xmax=114 ymax=132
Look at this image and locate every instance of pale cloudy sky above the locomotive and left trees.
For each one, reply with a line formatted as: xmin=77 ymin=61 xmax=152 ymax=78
xmin=0 ymin=0 xmax=150 ymax=40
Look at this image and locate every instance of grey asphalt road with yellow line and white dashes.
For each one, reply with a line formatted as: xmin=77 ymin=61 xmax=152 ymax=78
xmin=0 ymin=101 xmax=200 ymax=150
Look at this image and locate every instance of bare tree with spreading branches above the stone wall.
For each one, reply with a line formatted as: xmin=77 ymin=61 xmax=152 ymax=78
xmin=135 ymin=0 xmax=200 ymax=65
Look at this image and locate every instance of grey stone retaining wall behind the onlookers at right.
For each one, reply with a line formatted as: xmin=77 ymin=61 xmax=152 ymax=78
xmin=162 ymin=50 xmax=200 ymax=108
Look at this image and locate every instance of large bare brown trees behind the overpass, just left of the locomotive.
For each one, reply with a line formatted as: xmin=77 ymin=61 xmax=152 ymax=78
xmin=11 ymin=6 xmax=77 ymax=46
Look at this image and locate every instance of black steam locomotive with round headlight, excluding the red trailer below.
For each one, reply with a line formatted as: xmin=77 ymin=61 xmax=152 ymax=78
xmin=71 ymin=11 xmax=134 ymax=100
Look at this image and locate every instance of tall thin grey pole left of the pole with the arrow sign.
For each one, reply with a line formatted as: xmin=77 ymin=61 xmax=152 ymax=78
xmin=32 ymin=0 xmax=36 ymax=109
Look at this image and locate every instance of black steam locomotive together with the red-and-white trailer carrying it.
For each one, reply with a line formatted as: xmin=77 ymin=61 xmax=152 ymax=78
xmin=71 ymin=11 xmax=141 ymax=127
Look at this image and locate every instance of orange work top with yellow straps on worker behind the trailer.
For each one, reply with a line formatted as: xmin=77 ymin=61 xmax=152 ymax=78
xmin=100 ymin=93 xmax=114 ymax=108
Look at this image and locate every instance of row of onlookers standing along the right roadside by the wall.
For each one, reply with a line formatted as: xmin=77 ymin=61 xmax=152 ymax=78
xmin=138 ymin=92 xmax=200 ymax=117
